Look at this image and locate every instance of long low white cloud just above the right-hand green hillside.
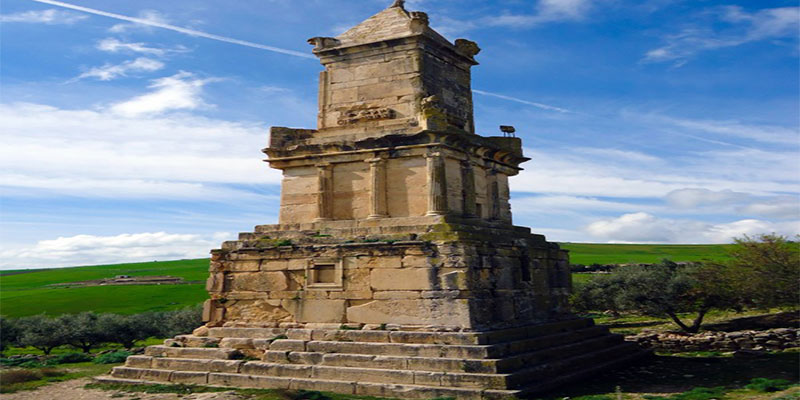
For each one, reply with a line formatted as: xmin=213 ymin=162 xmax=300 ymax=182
xmin=585 ymin=212 xmax=800 ymax=243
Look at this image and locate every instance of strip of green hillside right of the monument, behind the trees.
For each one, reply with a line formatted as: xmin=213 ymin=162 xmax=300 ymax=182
xmin=561 ymin=243 xmax=730 ymax=265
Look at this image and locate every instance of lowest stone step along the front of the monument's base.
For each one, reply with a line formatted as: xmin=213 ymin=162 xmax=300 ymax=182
xmin=103 ymin=367 xmax=521 ymax=400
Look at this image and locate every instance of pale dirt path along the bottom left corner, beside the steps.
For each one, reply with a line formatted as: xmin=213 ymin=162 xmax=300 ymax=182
xmin=0 ymin=378 xmax=245 ymax=400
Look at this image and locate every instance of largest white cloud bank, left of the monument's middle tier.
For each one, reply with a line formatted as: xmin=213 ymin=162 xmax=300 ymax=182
xmin=0 ymin=103 xmax=281 ymax=201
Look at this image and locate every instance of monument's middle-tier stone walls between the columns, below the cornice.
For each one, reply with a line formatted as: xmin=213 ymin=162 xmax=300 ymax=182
xmin=280 ymin=148 xmax=516 ymax=225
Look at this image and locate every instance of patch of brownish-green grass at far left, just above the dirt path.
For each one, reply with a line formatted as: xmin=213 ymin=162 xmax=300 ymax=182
xmin=0 ymin=362 xmax=113 ymax=393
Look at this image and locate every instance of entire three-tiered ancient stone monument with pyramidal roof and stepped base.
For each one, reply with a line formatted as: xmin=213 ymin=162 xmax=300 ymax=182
xmin=102 ymin=1 xmax=642 ymax=399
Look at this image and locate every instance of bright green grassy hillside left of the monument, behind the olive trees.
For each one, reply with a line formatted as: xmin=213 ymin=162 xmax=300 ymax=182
xmin=0 ymin=259 xmax=208 ymax=317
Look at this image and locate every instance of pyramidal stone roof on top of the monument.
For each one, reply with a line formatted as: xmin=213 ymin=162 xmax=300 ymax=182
xmin=336 ymin=2 xmax=452 ymax=47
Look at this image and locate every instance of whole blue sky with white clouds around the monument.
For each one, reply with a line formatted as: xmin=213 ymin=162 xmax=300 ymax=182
xmin=0 ymin=0 xmax=800 ymax=269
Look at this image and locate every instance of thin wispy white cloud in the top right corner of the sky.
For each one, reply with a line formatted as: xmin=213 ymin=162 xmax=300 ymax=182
xmin=643 ymin=6 xmax=800 ymax=66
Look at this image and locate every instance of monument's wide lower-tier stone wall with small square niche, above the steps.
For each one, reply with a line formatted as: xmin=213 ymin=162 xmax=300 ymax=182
xmin=205 ymin=233 xmax=569 ymax=330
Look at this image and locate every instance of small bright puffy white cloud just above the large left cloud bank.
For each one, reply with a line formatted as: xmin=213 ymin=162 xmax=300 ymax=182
xmin=111 ymin=72 xmax=218 ymax=117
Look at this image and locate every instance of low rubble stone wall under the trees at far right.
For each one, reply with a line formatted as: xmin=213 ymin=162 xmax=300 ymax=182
xmin=625 ymin=328 xmax=800 ymax=353
